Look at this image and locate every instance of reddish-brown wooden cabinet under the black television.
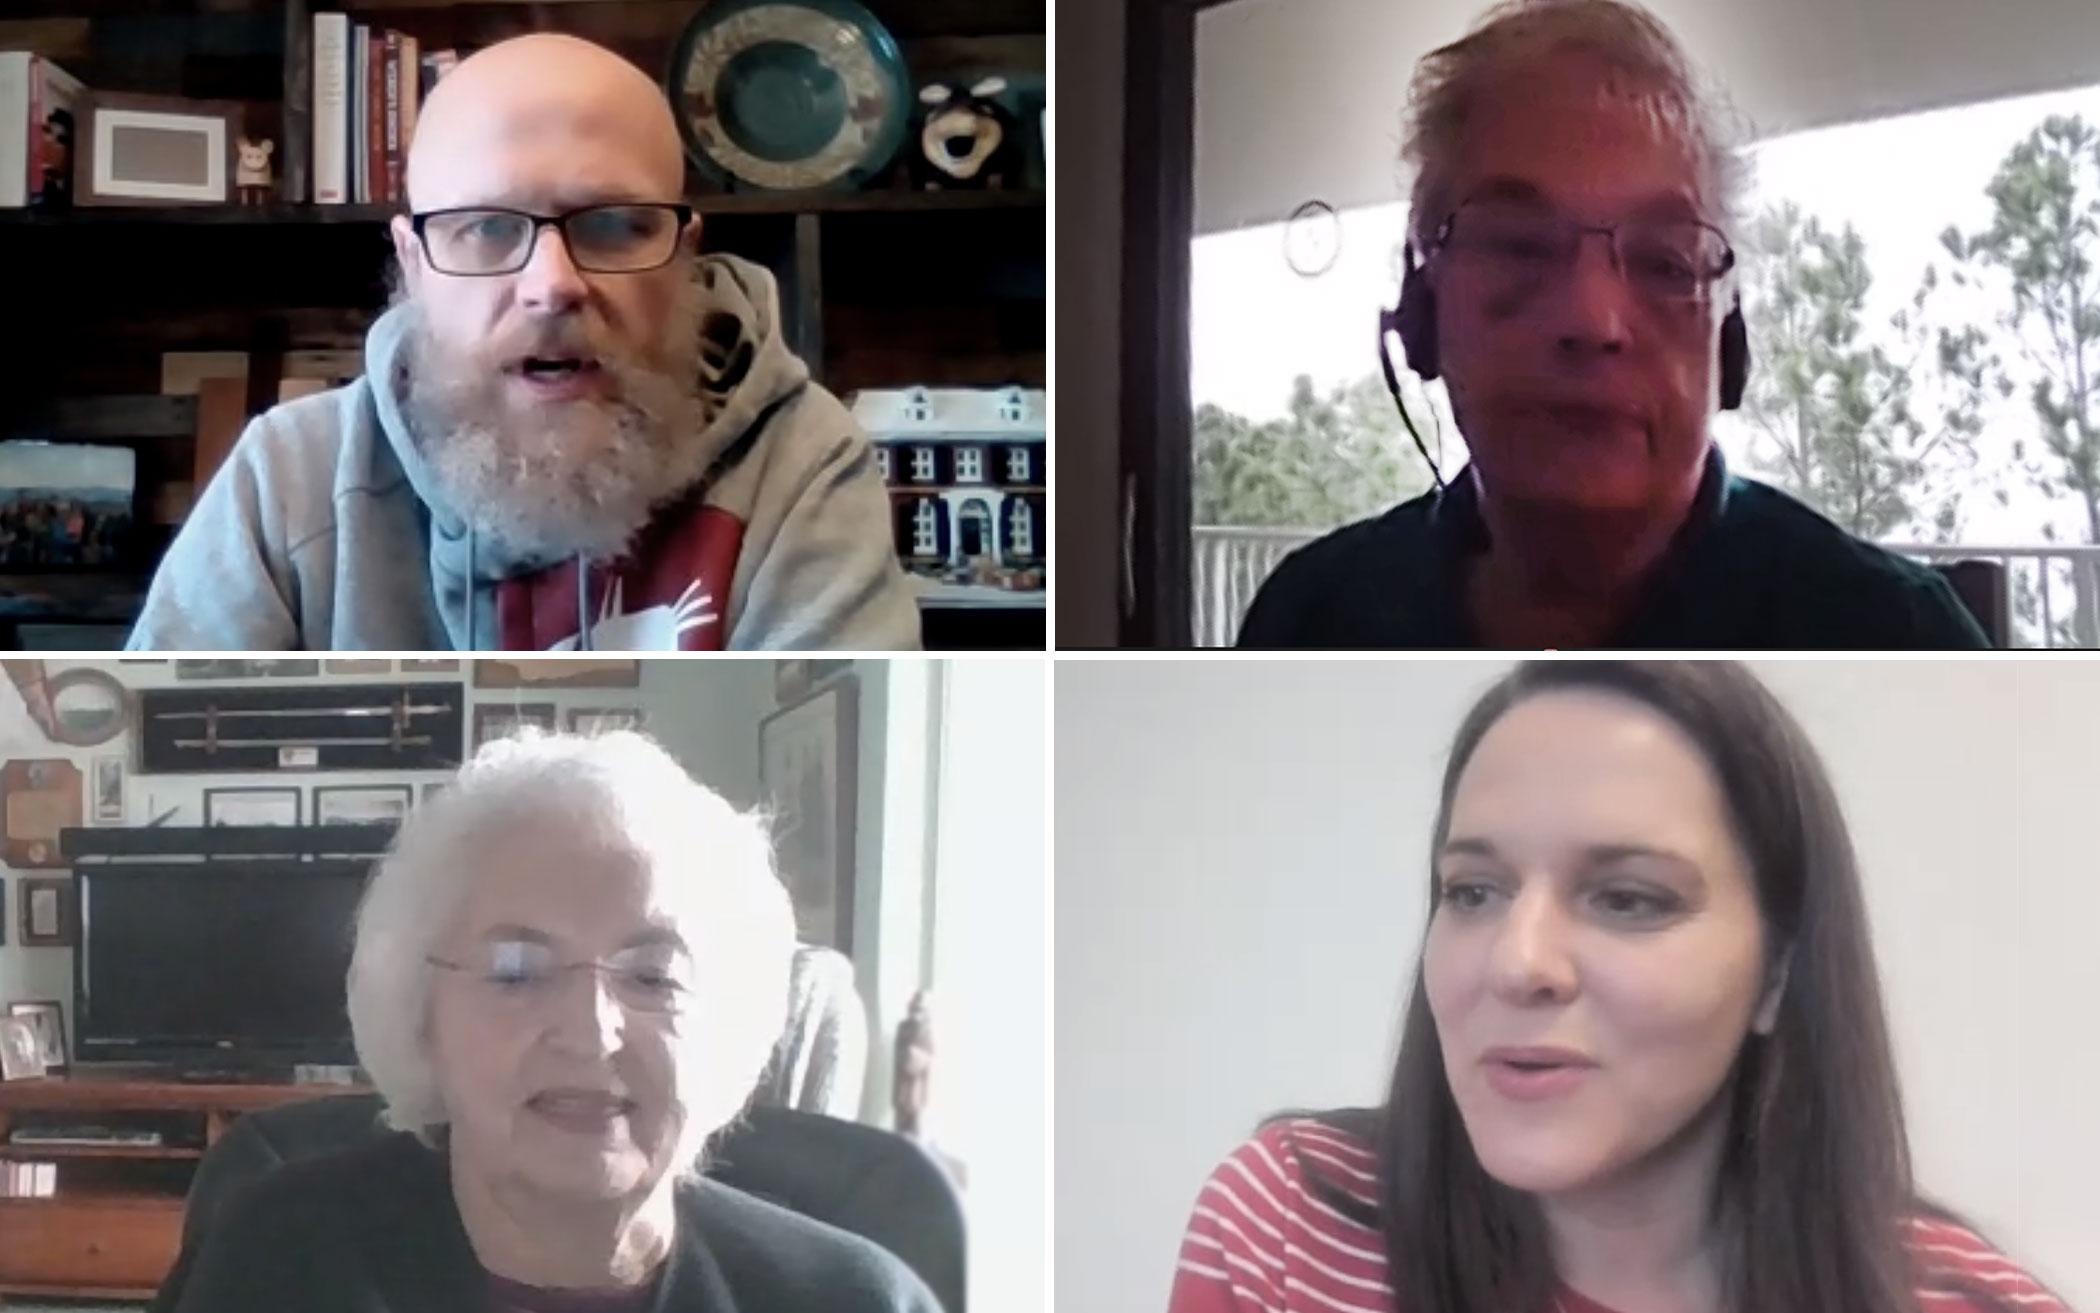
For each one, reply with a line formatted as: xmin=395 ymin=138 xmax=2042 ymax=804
xmin=0 ymin=1071 xmax=361 ymax=1302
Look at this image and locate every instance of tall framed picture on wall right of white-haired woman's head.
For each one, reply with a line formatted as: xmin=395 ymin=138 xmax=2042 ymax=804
xmin=758 ymin=676 xmax=859 ymax=954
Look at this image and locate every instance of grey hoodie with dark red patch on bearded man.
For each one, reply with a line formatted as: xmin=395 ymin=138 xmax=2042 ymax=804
xmin=130 ymin=254 xmax=920 ymax=651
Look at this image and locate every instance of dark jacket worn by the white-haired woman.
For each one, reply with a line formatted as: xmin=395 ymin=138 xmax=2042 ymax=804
xmin=176 ymin=1132 xmax=941 ymax=1313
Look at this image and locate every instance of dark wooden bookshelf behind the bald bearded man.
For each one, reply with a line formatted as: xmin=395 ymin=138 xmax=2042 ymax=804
xmin=0 ymin=0 xmax=1048 ymax=649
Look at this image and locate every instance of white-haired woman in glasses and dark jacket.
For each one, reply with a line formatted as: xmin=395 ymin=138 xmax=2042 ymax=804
xmin=168 ymin=733 xmax=939 ymax=1313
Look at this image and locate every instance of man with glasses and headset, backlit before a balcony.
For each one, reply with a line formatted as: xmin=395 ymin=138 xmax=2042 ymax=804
xmin=1239 ymin=0 xmax=1987 ymax=649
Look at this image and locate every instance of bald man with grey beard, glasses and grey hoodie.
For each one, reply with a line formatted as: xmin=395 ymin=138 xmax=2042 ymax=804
xmin=130 ymin=34 xmax=918 ymax=651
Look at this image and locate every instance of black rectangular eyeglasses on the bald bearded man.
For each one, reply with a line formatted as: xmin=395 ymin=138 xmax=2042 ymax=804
xmin=410 ymin=202 xmax=693 ymax=277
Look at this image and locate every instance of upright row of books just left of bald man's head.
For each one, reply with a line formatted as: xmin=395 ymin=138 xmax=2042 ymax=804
xmin=313 ymin=13 xmax=460 ymax=206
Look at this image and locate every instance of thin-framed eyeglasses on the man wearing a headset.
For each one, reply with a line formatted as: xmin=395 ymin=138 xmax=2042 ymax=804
xmin=1430 ymin=202 xmax=1735 ymax=305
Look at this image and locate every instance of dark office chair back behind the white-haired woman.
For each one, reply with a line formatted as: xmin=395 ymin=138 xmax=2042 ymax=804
xmin=151 ymin=1095 xmax=964 ymax=1313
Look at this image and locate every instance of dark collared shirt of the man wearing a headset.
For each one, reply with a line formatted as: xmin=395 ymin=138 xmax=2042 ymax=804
xmin=1239 ymin=447 xmax=1991 ymax=651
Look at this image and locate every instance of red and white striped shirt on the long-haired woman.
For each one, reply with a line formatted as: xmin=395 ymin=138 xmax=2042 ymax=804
xmin=1168 ymin=1118 xmax=2071 ymax=1313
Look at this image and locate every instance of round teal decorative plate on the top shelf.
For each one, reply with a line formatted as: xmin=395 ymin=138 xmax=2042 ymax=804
xmin=668 ymin=0 xmax=911 ymax=191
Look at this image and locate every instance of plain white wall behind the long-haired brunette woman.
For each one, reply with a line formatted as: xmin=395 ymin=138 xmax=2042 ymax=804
xmin=1054 ymin=660 xmax=2100 ymax=1313
